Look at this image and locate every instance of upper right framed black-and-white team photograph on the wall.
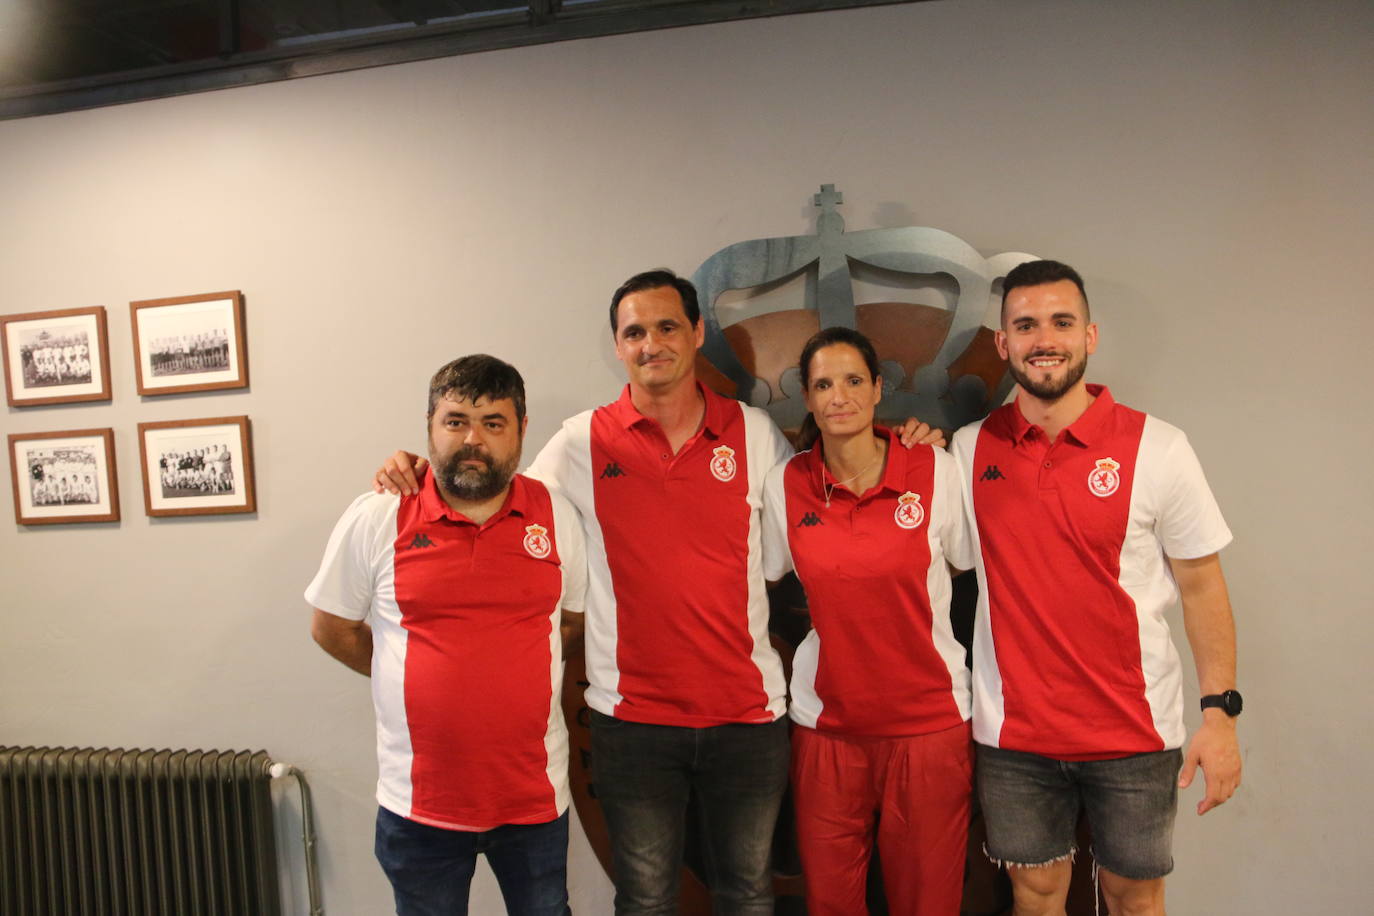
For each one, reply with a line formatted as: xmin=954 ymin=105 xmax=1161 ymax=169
xmin=129 ymin=290 xmax=249 ymax=396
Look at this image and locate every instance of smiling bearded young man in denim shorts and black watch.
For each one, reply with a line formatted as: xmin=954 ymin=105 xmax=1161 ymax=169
xmin=954 ymin=261 xmax=1241 ymax=916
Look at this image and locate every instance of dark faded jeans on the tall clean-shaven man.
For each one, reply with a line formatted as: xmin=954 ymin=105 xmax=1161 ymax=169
xmin=591 ymin=710 xmax=789 ymax=916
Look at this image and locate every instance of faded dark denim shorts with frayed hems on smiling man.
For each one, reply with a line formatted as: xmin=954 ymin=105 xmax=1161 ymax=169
xmin=977 ymin=744 xmax=1183 ymax=880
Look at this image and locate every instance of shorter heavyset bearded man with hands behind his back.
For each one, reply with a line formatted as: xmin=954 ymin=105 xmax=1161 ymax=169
xmin=305 ymin=356 xmax=585 ymax=916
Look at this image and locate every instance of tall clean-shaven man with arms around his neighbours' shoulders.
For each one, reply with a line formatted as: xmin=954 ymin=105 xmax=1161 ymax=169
xmin=375 ymin=269 xmax=943 ymax=916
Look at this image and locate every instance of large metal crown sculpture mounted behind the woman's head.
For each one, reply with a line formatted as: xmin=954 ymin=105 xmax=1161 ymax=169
xmin=692 ymin=184 xmax=1035 ymax=430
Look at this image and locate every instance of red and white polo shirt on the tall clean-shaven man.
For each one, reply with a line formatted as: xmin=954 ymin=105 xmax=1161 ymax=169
xmin=529 ymin=386 xmax=791 ymax=728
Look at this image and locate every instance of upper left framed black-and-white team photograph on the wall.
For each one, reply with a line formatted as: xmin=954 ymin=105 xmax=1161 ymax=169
xmin=0 ymin=305 xmax=110 ymax=407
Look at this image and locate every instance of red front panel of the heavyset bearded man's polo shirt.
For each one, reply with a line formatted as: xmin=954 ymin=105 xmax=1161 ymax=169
xmin=394 ymin=474 xmax=563 ymax=829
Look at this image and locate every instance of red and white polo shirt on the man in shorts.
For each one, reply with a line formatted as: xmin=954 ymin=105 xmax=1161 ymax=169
xmin=954 ymin=385 xmax=1231 ymax=759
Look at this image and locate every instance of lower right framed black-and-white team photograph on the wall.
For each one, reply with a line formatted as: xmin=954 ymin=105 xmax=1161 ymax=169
xmin=139 ymin=416 xmax=257 ymax=516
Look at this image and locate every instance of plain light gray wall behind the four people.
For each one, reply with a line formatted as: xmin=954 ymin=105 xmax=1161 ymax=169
xmin=0 ymin=0 xmax=1374 ymax=916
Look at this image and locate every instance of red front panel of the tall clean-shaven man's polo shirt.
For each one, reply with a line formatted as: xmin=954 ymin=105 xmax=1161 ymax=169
xmin=589 ymin=387 xmax=776 ymax=726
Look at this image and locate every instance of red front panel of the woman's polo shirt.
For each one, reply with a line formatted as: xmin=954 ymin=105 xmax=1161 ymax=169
xmin=783 ymin=428 xmax=967 ymax=736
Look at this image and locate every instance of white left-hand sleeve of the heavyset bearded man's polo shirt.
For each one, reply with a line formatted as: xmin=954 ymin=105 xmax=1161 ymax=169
xmin=305 ymin=493 xmax=401 ymax=621
